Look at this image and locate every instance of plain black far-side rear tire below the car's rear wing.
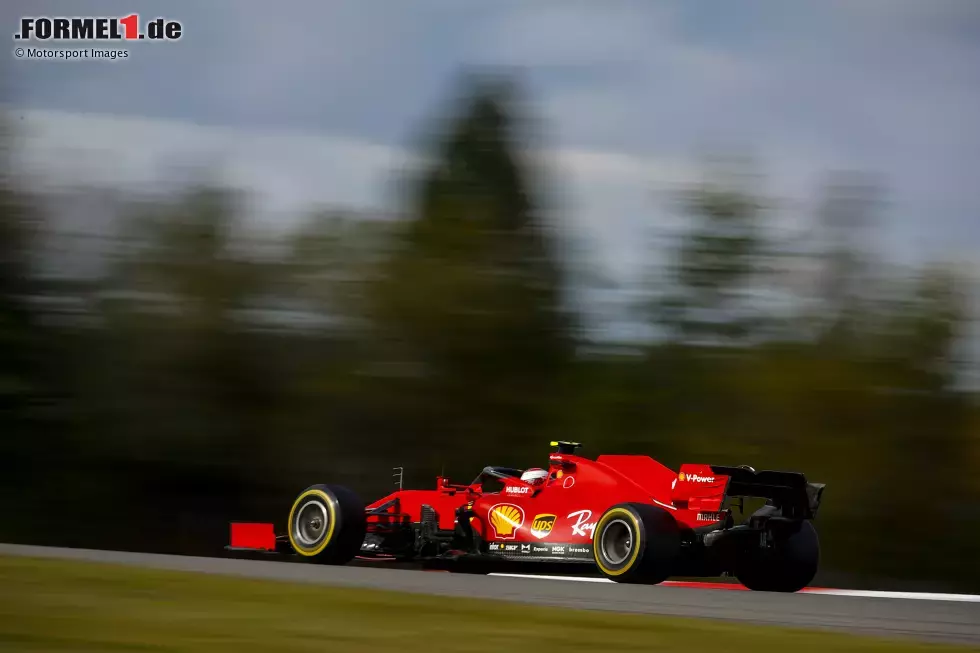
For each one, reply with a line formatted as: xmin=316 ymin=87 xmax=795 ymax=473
xmin=735 ymin=521 xmax=820 ymax=592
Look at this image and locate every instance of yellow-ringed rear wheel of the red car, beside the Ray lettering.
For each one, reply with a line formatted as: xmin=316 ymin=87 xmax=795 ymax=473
xmin=592 ymin=503 xmax=680 ymax=585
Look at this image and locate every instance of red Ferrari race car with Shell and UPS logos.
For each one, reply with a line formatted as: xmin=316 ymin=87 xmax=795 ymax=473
xmin=226 ymin=442 xmax=824 ymax=592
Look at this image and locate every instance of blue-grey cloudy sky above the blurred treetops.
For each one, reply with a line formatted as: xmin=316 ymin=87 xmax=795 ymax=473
xmin=0 ymin=0 xmax=980 ymax=286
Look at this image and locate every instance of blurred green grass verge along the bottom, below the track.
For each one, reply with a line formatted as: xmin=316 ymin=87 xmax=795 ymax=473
xmin=0 ymin=556 xmax=971 ymax=653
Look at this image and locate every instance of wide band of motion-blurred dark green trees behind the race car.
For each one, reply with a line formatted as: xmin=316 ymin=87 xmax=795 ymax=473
xmin=0 ymin=77 xmax=980 ymax=591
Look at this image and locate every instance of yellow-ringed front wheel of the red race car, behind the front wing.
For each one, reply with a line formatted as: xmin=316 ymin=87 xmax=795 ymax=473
xmin=288 ymin=485 xmax=366 ymax=565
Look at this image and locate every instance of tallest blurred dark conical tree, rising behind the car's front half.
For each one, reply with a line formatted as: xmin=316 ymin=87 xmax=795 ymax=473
xmin=362 ymin=79 xmax=574 ymax=474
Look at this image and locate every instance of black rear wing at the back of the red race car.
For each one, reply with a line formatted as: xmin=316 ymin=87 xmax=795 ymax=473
xmin=710 ymin=465 xmax=825 ymax=519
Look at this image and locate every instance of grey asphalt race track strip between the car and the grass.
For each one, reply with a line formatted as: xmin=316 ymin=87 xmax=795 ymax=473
xmin=0 ymin=544 xmax=980 ymax=646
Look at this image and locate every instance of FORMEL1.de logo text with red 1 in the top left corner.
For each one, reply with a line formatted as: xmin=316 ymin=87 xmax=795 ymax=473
xmin=14 ymin=14 xmax=184 ymax=41
